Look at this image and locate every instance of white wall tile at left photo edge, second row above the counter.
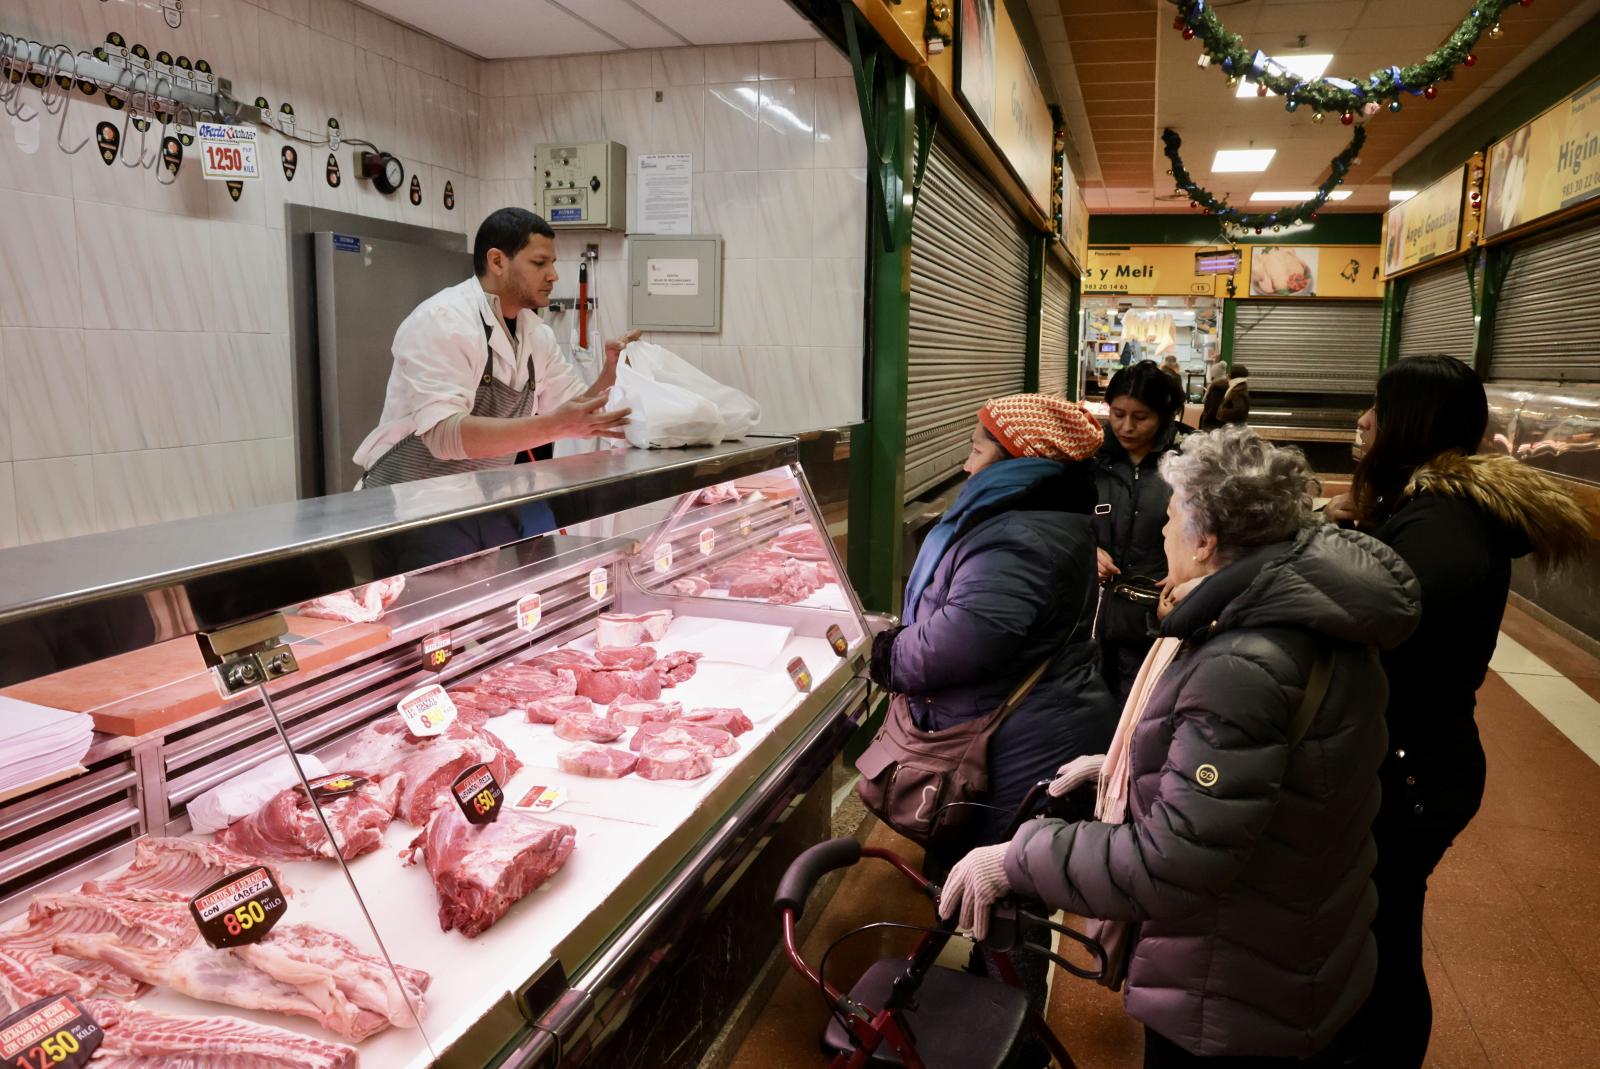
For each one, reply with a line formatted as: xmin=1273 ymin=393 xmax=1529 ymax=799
xmin=0 ymin=326 xmax=91 ymax=461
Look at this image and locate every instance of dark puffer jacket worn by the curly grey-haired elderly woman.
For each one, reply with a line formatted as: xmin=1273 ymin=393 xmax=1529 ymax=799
xmin=1005 ymin=526 xmax=1419 ymax=1058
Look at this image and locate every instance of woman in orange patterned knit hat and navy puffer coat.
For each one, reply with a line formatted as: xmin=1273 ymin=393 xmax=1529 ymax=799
xmin=870 ymin=394 xmax=1117 ymax=1069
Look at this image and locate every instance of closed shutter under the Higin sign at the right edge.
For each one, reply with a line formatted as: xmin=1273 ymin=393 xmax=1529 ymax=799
xmin=1490 ymin=219 xmax=1600 ymax=382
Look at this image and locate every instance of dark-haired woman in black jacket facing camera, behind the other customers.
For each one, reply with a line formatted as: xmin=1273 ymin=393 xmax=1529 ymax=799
xmin=1094 ymin=362 xmax=1184 ymax=704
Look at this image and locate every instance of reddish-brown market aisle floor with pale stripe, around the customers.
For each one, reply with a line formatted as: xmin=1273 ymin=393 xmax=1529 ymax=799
xmin=731 ymin=610 xmax=1600 ymax=1069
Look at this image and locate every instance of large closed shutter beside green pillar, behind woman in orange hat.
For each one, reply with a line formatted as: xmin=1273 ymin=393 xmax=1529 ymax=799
xmin=906 ymin=131 xmax=1027 ymax=501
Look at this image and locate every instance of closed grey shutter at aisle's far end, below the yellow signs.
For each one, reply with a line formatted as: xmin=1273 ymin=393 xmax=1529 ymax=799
xmin=1234 ymin=301 xmax=1384 ymax=394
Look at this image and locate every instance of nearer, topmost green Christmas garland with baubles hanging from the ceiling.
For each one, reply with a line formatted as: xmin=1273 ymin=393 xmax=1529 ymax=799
xmin=1173 ymin=0 xmax=1533 ymax=119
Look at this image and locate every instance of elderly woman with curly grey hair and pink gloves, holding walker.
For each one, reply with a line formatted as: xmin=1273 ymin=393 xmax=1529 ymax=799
xmin=939 ymin=427 xmax=1419 ymax=1066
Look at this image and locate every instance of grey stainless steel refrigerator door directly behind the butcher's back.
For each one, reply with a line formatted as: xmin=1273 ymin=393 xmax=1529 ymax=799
xmin=312 ymin=230 xmax=472 ymax=493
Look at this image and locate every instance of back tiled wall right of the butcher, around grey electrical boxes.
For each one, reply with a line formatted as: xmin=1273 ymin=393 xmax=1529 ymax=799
xmin=480 ymin=42 xmax=867 ymax=430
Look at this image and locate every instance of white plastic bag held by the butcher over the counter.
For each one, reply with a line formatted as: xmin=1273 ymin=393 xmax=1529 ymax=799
xmin=606 ymin=341 xmax=762 ymax=450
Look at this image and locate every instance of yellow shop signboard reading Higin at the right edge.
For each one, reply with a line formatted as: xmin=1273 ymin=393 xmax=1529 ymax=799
xmin=1483 ymin=78 xmax=1600 ymax=238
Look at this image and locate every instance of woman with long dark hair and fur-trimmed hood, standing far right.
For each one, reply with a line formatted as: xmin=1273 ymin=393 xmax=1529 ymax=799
xmin=1328 ymin=357 xmax=1590 ymax=1069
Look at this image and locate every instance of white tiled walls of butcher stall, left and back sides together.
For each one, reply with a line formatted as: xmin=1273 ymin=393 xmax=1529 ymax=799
xmin=0 ymin=0 xmax=866 ymax=546
